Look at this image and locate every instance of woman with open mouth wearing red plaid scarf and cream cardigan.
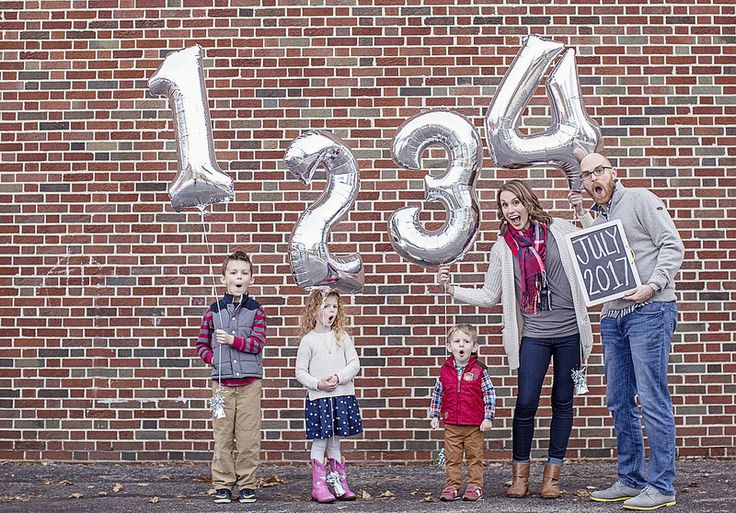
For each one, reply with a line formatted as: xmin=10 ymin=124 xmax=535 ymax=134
xmin=438 ymin=180 xmax=593 ymax=498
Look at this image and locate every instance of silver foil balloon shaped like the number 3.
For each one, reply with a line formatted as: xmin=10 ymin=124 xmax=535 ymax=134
xmin=389 ymin=110 xmax=483 ymax=267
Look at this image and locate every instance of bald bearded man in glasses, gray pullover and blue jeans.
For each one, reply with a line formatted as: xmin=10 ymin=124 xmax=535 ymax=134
xmin=568 ymin=153 xmax=685 ymax=511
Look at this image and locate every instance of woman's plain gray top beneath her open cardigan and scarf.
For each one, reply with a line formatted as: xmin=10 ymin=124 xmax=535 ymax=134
xmin=514 ymin=230 xmax=578 ymax=338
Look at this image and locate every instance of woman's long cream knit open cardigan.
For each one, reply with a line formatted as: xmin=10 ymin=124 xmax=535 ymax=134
xmin=453 ymin=218 xmax=593 ymax=370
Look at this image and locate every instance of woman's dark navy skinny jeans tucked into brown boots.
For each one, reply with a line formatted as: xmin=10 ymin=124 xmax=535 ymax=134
xmin=513 ymin=333 xmax=580 ymax=464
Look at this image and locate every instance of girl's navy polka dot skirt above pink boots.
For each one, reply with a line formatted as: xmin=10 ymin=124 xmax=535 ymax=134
xmin=304 ymin=395 xmax=363 ymax=440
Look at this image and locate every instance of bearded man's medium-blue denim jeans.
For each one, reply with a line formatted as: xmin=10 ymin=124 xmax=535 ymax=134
xmin=601 ymin=301 xmax=677 ymax=495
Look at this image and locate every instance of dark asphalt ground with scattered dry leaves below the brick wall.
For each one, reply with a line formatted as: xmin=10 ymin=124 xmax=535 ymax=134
xmin=0 ymin=460 xmax=736 ymax=513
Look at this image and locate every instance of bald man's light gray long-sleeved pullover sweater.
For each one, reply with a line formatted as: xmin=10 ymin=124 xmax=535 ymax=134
xmin=580 ymin=182 xmax=685 ymax=314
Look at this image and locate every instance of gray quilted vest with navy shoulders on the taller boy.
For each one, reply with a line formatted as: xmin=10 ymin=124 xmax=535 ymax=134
xmin=210 ymin=294 xmax=263 ymax=380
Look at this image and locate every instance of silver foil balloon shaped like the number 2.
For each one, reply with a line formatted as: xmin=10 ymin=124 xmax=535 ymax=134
xmin=284 ymin=130 xmax=364 ymax=292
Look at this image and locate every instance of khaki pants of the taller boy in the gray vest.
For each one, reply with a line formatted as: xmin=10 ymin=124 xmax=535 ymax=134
xmin=212 ymin=379 xmax=261 ymax=490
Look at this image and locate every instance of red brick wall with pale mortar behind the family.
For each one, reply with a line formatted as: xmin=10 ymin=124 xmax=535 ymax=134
xmin=0 ymin=0 xmax=736 ymax=462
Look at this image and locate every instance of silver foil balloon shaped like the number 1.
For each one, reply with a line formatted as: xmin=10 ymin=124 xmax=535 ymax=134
xmin=148 ymin=45 xmax=234 ymax=212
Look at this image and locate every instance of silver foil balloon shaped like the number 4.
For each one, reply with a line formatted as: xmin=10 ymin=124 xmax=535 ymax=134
xmin=486 ymin=36 xmax=601 ymax=191
